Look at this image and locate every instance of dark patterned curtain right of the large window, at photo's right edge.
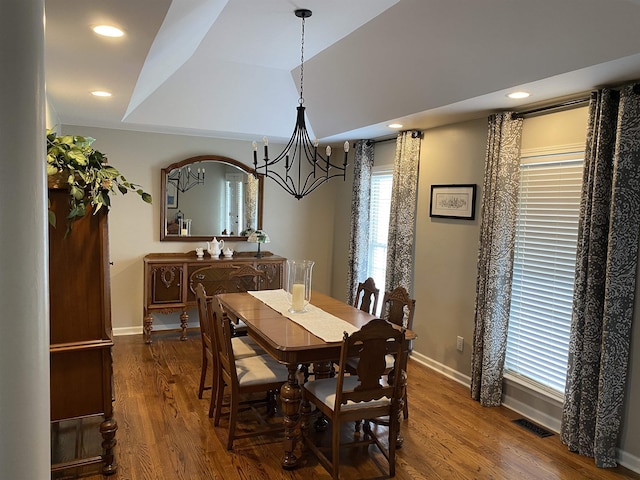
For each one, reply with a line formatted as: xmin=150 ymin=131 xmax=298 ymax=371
xmin=562 ymin=86 xmax=640 ymax=467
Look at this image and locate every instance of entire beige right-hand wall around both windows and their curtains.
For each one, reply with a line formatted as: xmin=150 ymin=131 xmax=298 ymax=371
xmin=332 ymin=108 xmax=640 ymax=471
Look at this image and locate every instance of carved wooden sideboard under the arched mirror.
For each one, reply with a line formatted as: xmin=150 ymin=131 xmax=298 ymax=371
xmin=143 ymin=252 xmax=286 ymax=343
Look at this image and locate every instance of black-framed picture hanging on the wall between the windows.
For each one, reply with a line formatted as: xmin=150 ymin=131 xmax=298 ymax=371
xmin=429 ymin=184 xmax=476 ymax=220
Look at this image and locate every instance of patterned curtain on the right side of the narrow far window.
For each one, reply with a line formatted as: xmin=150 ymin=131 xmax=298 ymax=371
xmin=385 ymin=131 xmax=421 ymax=293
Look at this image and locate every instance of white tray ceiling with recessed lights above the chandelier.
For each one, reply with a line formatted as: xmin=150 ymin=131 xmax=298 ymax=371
xmin=45 ymin=0 xmax=640 ymax=142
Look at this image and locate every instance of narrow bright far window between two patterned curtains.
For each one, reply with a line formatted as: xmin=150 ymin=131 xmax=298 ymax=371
xmin=367 ymin=167 xmax=393 ymax=314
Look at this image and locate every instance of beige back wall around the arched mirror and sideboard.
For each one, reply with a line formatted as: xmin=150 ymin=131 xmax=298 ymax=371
xmin=58 ymin=125 xmax=343 ymax=334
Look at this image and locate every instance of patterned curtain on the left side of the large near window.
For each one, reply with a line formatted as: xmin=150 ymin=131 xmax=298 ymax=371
xmin=471 ymin=112 xmax=522 ymax=407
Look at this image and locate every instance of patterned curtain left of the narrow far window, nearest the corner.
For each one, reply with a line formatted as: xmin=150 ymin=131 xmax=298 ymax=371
xmin=347 ymin=140 xmax=374 ymax=305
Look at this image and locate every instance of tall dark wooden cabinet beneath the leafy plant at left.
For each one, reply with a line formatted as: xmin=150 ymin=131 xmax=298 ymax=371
xmin=49 ymin=188 xmax=117 ymax=475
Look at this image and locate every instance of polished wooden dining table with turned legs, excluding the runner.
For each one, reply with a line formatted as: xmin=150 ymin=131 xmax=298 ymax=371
xmin=217 ymin=291 xmax=415 ymax=469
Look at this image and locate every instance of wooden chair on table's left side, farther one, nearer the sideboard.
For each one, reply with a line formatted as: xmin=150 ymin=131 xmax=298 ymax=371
xmin=195 ymin=283 xmax=267 ymax=417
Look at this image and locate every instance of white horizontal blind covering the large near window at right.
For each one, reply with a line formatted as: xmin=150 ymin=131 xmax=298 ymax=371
xmin=505 ymin=152 xmax=583 ymax=394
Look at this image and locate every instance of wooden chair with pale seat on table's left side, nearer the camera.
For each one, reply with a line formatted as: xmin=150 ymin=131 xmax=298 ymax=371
xmin=212 ymin=297 xmax=289 ymax=450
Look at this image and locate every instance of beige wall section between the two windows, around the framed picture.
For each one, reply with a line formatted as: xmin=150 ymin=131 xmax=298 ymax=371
xmin=414 ymin=119 xmax=487 ymax=376
